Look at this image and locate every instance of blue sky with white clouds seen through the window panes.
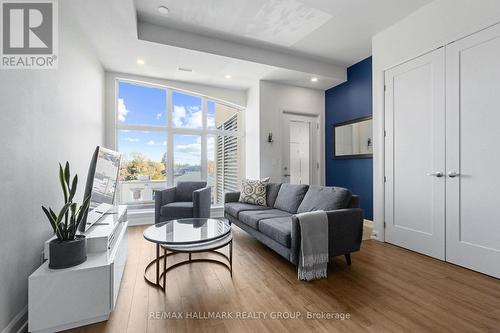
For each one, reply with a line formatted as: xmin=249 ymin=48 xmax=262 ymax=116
xmin=118 ymin=82 xmax=215 ymax=165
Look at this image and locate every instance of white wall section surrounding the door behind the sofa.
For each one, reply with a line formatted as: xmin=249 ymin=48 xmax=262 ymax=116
xmin=259 ymin=81 xmax=325 ymax=184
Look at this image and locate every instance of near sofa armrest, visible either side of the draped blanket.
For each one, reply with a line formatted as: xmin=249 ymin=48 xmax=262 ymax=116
xmin=290 ymin=208 xmax=363 ymax=265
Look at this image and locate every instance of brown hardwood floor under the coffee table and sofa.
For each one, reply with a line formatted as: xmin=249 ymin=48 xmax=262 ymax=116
xmin=66 ymin=226 xmax=500 ymax=333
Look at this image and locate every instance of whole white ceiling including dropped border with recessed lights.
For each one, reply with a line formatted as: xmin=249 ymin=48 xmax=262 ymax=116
xmin=67 ymin=0 xmax=430 ymax=89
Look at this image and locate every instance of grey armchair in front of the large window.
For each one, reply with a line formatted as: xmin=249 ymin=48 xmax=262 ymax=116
xmin=155 ymin=182 xmax=211 ymax=224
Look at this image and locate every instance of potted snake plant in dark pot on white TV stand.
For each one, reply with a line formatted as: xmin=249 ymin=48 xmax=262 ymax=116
xmin=42 ymin=162 xmax=90 ymax=269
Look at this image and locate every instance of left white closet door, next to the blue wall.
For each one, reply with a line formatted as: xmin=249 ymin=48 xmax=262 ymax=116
xmin=385 ymin=49 xmax=445 ymax=260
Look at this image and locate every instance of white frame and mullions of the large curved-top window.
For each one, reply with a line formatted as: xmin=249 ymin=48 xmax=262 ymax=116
xmin=113 ymin=77 xmax=245 ymax=200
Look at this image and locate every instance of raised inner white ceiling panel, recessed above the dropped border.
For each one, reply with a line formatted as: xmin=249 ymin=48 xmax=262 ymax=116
xmin=135 ymin=0 xmax=432 ymax=66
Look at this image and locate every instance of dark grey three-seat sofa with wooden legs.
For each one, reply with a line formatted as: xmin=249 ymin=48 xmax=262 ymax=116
xmin=224 ymin=183 xmax=363 ymax=265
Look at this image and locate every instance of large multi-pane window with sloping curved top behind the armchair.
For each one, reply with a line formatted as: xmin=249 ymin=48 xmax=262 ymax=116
xmin=116 ymin=80 xmax=243 ymax=208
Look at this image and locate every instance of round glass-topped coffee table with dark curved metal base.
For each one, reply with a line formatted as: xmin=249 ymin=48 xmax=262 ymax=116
xmin=144 ymin=218 xmax=233 ymax=290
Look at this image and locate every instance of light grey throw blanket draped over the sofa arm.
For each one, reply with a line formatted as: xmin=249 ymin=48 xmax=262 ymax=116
xmin=296 ymin=211 xmax=329 ymax=281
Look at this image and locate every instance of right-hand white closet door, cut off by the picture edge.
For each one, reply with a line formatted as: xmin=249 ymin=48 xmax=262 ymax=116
xmin=446 ymin=26 xmax=500 ymax=277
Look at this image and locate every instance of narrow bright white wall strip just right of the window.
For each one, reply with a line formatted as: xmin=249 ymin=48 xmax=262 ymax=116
xmin=245 ymin=82 xmax=261 ymax=179
